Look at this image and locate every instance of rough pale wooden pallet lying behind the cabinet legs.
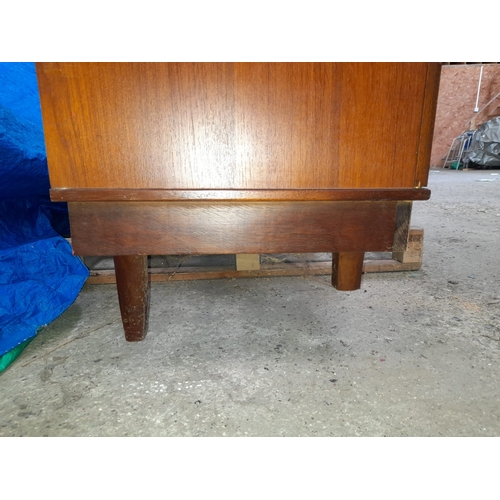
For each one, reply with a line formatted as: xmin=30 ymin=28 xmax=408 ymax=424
xmin=87 ymin=228 xmax=424 ymax=285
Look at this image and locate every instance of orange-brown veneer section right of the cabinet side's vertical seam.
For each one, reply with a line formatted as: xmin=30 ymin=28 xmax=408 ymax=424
xmin=338 ymin=63 xmax=427 ymax=188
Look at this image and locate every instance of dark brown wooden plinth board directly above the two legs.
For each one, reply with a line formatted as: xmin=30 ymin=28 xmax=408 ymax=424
xmin=69 ymin=201 xmax=397 ymax=255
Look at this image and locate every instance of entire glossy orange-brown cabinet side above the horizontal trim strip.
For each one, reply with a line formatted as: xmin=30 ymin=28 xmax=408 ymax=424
xmin=37 ymin=63 xmax=439 ymax=190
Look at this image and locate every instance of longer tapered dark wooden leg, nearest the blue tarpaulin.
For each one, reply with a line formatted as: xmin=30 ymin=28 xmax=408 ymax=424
xmin=114 ymin=255 xmax=149 ymax=342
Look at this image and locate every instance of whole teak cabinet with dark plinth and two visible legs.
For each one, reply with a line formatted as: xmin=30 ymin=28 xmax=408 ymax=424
xmin=37 ymin=63 xmax=440 ymax=340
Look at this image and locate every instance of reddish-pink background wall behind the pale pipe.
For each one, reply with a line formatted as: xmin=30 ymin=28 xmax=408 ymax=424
xmin=431 ymin=64 xmax=500 ymax=167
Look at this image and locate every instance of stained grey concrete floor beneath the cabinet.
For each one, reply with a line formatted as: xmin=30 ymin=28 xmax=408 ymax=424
xmin=0 ymin=170 xmax=500 ymax=436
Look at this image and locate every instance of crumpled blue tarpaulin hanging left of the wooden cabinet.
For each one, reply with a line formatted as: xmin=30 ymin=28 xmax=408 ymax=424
xmin=0 ymin=63 xmax=89 ymax=370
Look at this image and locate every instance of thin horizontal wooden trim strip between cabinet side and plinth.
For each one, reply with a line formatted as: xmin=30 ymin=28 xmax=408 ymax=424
xmin=51 ymin=188 xmax=431 ymax=201
